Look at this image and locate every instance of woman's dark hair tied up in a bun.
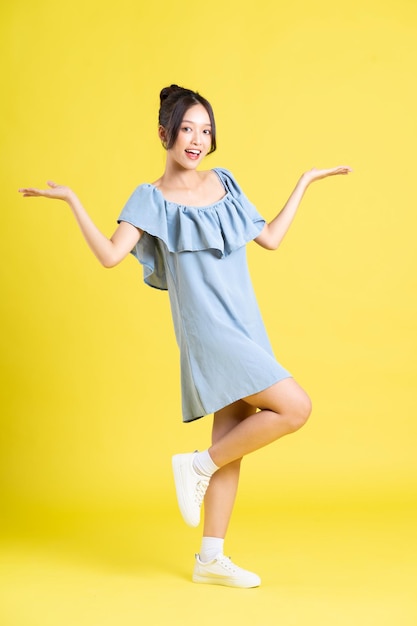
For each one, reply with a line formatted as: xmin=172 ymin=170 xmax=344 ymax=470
xmin=158 ymin=85 xmax=216 ymax=154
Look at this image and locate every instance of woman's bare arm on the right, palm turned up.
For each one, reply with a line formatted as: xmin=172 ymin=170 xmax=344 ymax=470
xmin=255 ymin=165 xmax=352 ymax=250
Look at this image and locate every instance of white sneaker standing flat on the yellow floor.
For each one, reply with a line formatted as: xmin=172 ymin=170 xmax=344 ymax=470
xmin=193 ymin=554 xmax=261 ymax=589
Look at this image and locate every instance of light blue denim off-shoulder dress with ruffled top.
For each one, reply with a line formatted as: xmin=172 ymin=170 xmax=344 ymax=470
xmin=118 ymin=168 xmax=291 ymax=422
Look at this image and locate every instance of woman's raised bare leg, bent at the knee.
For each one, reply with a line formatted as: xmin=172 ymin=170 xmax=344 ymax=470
xmin=209 ymin=378 xmax=311 ymax=468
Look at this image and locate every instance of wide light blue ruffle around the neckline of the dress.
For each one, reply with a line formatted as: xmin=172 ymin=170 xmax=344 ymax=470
xmin=118 ymin=168 xmax=265 ymax=289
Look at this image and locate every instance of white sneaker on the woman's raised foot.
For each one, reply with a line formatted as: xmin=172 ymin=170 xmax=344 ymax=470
xmin=172 ymin=452 xmax=210 ymax=526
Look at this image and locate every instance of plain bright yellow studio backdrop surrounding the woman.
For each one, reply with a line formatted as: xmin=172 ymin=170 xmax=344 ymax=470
xmin=0 ymin=0 xmax=417 ymax=626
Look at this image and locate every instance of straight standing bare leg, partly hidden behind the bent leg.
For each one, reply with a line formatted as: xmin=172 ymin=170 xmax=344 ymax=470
xmin=203 ymin=400 xmax=255 ymax=538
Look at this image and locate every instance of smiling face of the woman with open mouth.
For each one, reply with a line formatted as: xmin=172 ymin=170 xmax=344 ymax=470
xmin=168 ymin=104 xmax=211 ymax=169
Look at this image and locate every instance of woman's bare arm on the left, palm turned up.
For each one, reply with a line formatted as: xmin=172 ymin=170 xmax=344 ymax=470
xmin=19 ymin=181 xmax=142 ymax=267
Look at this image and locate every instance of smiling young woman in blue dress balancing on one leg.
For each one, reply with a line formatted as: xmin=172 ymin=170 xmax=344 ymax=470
xmin=19 ymin=85 xmax=351 ymax=587
